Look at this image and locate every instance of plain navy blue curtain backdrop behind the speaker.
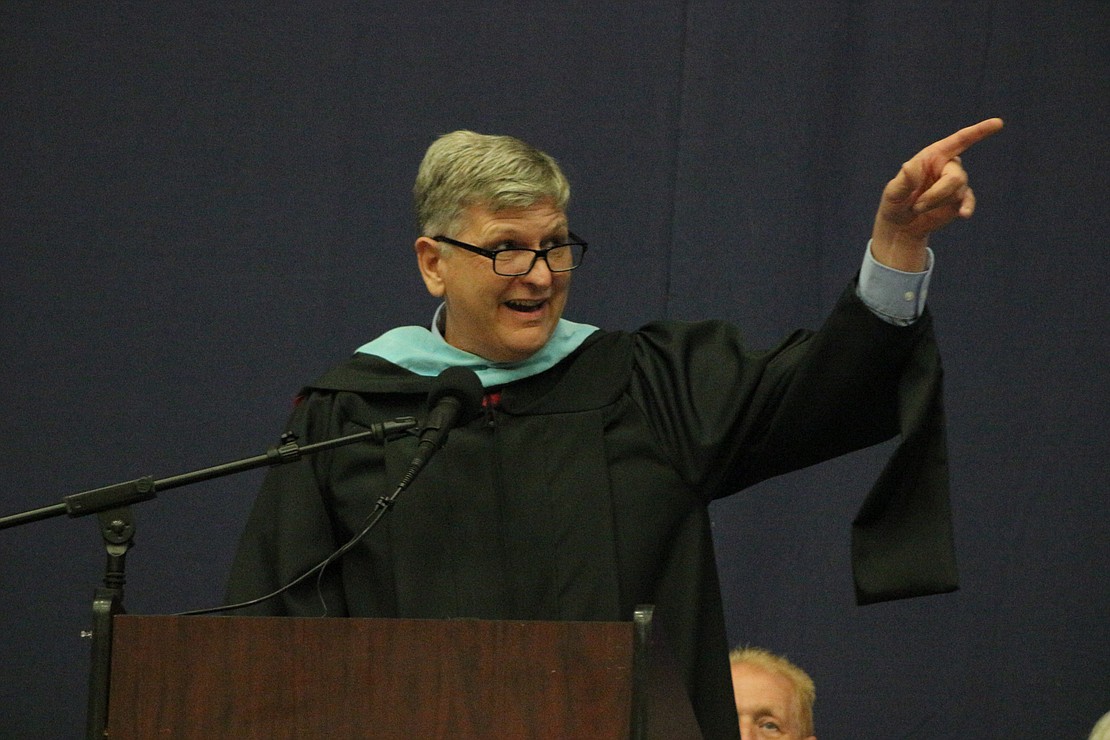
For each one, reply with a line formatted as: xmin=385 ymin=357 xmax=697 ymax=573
xmin=0 ymin=0 xmax=1110 ymax=740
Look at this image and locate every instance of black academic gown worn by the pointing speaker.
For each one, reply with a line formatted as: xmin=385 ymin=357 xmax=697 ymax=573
xmin=228 ymin=281 xmax=956 ymax=738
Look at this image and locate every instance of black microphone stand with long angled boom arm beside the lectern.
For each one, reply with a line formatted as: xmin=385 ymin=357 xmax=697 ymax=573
xmin=0 ymin=416 xmax=416 ymax=740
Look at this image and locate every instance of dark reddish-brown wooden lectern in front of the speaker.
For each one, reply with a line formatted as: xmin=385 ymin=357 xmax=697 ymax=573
xmin=107 ymin=608 xmax=700 ymax=740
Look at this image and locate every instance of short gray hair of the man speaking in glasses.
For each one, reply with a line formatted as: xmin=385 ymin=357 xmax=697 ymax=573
xmin=413 ymin=131 xmax=571 ymax=236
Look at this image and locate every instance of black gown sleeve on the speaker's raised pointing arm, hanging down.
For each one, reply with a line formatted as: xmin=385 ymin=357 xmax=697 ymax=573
xmin=634 ymin=280 xmax=957 ymax=604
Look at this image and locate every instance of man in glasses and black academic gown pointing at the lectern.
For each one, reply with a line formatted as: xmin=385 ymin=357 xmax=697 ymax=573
xmin=228 ymin=119 xmax=1001 ymax=738
